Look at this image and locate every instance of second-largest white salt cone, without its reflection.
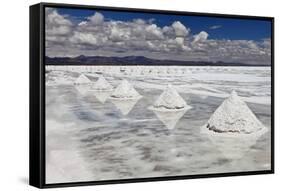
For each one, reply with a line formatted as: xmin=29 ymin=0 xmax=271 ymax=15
xmin=153 ymin=84 xmax=187 ymax=110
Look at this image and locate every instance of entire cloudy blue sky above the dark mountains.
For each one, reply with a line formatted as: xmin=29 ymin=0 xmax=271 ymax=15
xmin=45 ymin=8 xmax=271 ymax=64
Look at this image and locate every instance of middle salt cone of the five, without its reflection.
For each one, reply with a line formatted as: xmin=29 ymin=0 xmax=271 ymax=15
xmin=110 ymin=80 xmax=141 ymax=99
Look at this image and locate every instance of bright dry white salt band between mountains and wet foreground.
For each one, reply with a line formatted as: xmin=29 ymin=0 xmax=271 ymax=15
xmin=46 ymin=66 xmax=271 ymax=105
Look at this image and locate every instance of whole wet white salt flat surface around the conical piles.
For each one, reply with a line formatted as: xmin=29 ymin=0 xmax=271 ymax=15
xmin=46 ymin=66 xmax=271 ymax=183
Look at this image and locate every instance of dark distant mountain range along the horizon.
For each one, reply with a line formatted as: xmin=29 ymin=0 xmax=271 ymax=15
xmin=45 ymin=55 xmax=268 ymax=66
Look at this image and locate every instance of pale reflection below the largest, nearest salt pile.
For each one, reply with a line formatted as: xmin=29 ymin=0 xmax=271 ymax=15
xmin=200 ymin=126 xmax=268 ymax=160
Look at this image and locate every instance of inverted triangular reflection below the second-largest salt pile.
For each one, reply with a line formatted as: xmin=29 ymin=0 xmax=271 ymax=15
xmin=151 ymin=108 xmax=190 ymax=130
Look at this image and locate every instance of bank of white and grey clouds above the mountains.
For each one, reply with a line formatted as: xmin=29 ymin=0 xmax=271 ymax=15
xmin=46 ymin=9 xmax=271 ymax=64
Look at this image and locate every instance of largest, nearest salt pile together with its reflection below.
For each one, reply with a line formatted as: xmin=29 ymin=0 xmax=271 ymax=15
xmin=200 ymin=91 xmax=268 ymax=159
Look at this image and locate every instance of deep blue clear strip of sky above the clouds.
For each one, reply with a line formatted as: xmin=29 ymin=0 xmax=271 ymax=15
xmin=58 ymin=8 xmax=271 ymax=41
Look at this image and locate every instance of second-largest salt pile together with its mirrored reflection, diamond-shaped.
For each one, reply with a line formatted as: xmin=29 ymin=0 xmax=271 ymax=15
xmin=148 ymin=84 xmax=192 ymax=130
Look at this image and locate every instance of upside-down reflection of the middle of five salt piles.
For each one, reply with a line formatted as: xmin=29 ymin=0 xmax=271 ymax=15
xmin=110 ymin=98 xmax=141 ymax=115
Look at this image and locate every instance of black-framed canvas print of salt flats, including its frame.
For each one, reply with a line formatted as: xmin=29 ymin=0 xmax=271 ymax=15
xmin=30 ymin=3 xmax=274 ymax=188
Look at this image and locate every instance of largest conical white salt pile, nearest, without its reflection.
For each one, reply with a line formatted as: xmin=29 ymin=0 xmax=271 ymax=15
xmin=206 ymin=91 xmax=264 ymax=134
